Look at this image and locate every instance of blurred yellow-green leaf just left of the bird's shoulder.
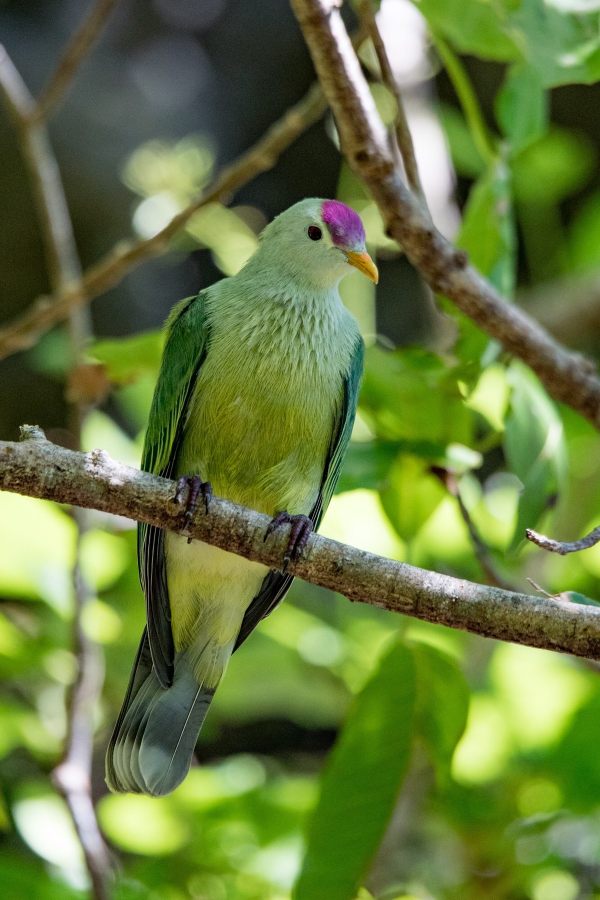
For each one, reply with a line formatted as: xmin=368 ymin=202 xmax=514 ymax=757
xmin=88 ymin=331 xmax=164 ymax=384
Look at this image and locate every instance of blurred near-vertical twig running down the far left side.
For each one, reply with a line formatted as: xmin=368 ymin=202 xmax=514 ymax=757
xmin=0 ymin=45 xmax=111 ymax=900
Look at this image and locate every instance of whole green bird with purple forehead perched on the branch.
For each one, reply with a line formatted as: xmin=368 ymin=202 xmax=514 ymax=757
xmin=106 ymin=198 xmax=379 ymax=796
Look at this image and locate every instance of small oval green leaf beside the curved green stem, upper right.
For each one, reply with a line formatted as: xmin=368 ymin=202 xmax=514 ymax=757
xmin=496 ymin=63 xmax=548 ymax=154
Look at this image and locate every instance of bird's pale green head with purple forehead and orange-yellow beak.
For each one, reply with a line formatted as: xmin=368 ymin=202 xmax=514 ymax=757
xmin=254 ymin=198 xmax=379 ymax=289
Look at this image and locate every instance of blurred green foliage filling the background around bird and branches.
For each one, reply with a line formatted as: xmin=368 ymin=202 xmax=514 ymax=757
xmin=0 ymin=0 xmax=600 ymax=900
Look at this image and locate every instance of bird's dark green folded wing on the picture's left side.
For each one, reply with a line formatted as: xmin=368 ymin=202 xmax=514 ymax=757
xmin=138 ymin=293 xmax=208 ymax=687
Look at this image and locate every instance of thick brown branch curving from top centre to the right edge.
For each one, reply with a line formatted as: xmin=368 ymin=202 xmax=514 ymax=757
xmin=291 ymin=0 xmax=600 ymax=427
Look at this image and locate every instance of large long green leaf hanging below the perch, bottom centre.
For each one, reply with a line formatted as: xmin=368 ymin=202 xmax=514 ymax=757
xmin=293 ymin=644 xmax=416 ymax=900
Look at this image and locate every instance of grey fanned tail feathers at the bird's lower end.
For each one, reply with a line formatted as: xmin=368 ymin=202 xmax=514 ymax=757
xmin=106 ymin=630 xmax=214 ymax=797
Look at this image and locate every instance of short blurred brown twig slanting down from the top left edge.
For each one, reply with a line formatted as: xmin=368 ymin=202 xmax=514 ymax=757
xmin=29 ymin=0 xmax=119 ymax=123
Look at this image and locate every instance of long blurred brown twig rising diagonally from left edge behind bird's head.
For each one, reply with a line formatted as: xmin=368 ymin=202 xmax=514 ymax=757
xmin=0 ymin=78 xmax=327 ymax=359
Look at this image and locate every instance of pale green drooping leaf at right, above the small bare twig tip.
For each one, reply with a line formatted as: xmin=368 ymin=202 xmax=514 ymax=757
xmin=504 ymin=362 xmax=567 ymax=552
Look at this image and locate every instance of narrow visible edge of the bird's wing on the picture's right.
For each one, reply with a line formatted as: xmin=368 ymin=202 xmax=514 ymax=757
xmin=234 ymin=337 xmax=364 ymax=650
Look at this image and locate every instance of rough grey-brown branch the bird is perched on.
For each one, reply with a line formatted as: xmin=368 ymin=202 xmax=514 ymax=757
xmin=0 ymin=427 xmax=600 ymax=660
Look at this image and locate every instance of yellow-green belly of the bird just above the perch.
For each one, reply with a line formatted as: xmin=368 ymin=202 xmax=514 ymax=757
xmin=177 ymin=348 xmax=343 ymax=515
